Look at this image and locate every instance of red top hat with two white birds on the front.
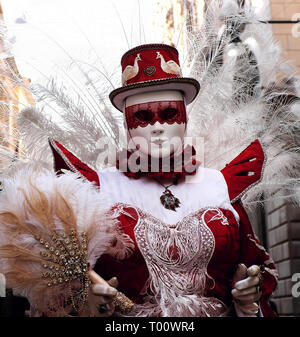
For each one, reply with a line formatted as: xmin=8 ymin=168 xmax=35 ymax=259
xmin=109 ymin=44 xmax=200 ymax=111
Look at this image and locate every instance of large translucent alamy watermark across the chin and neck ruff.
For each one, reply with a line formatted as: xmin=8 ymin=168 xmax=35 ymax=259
xmin=96 ymin=136 xmax=204 ymax=181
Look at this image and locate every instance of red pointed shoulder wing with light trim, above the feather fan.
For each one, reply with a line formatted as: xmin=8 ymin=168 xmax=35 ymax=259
xmin=49 ymin=138 xmax=100 ymax=186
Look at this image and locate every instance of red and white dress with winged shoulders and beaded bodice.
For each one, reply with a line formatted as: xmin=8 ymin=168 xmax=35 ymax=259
xmin=50 ymin=140 xmax=277 ymax=317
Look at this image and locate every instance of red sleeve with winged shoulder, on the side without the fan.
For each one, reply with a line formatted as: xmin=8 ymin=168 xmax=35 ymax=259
xmin=221 ymin=140 xmax=278 ymax=317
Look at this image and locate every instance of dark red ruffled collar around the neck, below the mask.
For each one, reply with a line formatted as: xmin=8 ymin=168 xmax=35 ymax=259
xmin=116 ymin=145 xmax=201 ymax=179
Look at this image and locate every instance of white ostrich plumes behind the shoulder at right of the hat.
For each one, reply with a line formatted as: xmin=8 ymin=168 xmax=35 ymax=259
xmin=184 ymin=1 xmax=300 ymax=207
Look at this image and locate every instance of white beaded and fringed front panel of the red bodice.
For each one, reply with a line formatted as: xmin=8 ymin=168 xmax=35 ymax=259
xmin=129 ymin=208 xmax=227 ymax=317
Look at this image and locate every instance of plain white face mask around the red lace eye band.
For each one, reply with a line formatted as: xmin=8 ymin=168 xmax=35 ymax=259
xmin=124 ymin=91 xmax=186 ymax=158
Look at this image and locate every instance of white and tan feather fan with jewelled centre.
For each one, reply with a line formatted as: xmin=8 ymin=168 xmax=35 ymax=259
xmin=0 ymin=166 xmax=115 ymax=316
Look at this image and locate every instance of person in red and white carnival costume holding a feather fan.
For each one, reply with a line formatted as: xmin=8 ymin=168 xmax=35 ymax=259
xmin=0 ymin=0 xmax=298 ymax=317
